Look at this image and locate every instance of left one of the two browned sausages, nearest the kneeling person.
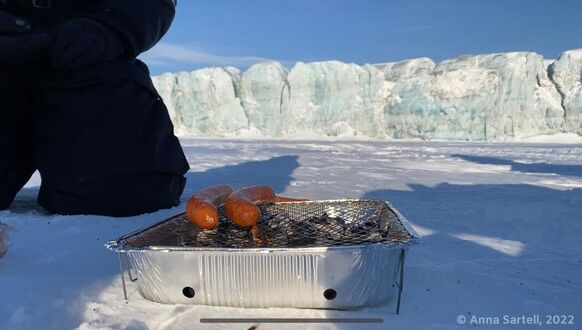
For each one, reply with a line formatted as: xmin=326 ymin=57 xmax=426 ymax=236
xmin=186 ymin=184 xmax=233 ymax=229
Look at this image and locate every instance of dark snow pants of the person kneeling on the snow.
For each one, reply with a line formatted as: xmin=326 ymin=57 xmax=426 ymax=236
xmin=0 ymin=60 xmax=188 ymax=216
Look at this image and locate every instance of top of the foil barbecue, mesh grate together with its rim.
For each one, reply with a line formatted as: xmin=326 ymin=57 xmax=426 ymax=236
xmin=106 ymin=199 xmax=420 ymax=253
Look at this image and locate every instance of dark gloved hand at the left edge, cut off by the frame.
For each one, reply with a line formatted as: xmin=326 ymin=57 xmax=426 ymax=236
xmin=0 ymin=33 xmax=53 ymax=67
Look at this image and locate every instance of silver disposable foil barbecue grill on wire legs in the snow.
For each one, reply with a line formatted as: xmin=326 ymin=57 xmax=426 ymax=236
xmin=107 ymin=200 xmax=420 ymax=311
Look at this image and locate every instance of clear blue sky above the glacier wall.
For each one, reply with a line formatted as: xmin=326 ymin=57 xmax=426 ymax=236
xmin=141 ymin=0 xmax=582 ymax=74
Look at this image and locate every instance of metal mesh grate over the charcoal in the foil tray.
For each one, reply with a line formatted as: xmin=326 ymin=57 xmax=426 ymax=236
xmin=124 ymin=200 xmax=412 ymax=248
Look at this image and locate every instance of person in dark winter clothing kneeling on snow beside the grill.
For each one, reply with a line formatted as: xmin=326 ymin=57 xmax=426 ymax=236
xmin=0 ymin=0 xmax=189 ymax=216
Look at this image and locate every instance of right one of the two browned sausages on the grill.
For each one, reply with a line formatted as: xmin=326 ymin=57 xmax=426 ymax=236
xmin=224 ymin=186 xmax=275 ymax=228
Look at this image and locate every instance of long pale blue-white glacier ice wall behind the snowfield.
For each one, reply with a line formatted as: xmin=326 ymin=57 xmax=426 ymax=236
xmin=153 ymin=49 xmax=582 ymax=141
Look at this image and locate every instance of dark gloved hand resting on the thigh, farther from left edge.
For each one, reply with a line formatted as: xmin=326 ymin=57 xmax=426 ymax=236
xmin=49 ymin=18 xmax=123 ymax=70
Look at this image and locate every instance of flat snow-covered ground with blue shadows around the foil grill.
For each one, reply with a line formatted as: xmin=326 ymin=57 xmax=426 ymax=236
xmin=0 ymin=140 xmax=582 ymax=329
